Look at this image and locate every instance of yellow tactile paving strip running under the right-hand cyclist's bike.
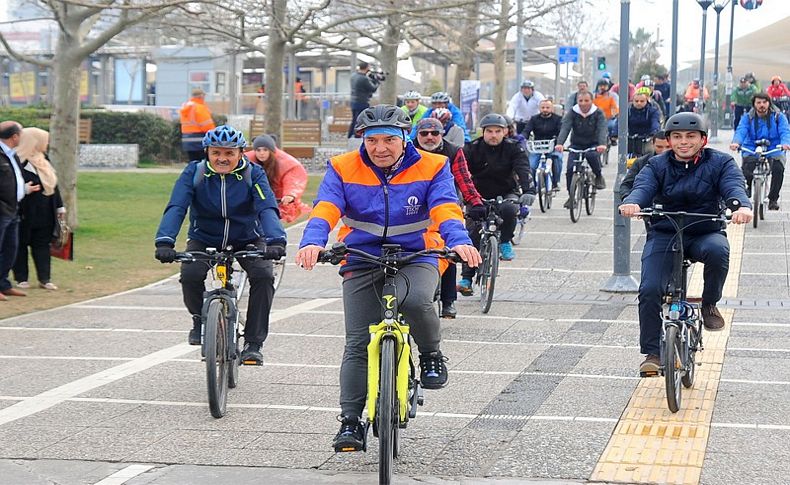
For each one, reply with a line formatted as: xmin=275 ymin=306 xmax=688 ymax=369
xmin=590 ymin=225 xmax=744 ymax=485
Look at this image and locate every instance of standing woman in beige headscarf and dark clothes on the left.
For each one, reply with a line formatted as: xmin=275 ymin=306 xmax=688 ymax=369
xmin=13 ymin=128 xmax=66 ymax=290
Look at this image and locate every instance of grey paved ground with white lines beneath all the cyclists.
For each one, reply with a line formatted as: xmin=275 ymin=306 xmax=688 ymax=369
xmin=0 ymin=132 xmax=790 ymax=485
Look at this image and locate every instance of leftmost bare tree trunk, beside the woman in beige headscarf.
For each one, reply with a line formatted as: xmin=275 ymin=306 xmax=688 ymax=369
xmin=49 ymin=35 xmax=81 ymax=228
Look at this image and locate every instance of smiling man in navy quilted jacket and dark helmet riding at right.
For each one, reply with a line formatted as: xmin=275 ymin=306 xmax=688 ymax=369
xmin=619 ymin=113 xmax=752 ymax=376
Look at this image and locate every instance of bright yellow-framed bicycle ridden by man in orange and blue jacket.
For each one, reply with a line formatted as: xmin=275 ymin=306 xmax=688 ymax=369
xmin=318 ymin=242 xmax=460 ymax=484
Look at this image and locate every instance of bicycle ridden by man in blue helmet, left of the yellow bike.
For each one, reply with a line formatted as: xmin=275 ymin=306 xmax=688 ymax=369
xmin=176 ymin=247 xmax=276 ymax=418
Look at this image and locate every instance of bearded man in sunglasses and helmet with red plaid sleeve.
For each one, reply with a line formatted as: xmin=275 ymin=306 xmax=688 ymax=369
xmin=414 ymin=118 xmax=486 ymax=318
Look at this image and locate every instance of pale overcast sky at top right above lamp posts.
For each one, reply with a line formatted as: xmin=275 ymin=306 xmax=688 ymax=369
xmin=608 ymin=0 xmax=790 ymax=66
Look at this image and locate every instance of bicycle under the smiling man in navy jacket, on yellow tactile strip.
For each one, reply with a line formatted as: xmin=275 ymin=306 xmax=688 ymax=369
xmin=636 ymin=204 xmax=737 ymax=413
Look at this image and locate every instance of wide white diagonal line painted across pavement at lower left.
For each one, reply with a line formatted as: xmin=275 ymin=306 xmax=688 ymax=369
xmin=0 ymin=298 xmax=338 ymax=426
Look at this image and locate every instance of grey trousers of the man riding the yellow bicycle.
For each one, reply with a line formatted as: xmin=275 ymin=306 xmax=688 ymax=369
xmin=340 ymin=263 xmax=441 ymax=417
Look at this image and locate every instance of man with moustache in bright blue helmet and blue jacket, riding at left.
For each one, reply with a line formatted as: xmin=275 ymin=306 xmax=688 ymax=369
xmin=155 ymin=125 xmax=286 ymax=363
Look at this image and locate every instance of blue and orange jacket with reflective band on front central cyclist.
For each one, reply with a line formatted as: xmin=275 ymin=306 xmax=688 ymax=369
xmin=299 ymin=142 xmax=472 ymax=274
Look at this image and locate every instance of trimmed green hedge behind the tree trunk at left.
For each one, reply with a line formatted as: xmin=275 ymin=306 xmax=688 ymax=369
xmin=0 ymin=107 xmax=227 ymax=163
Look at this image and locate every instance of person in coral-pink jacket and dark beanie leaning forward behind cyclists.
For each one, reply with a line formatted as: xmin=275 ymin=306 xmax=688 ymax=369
xmin=244 ymin=135 xmax=310 ymax=222
